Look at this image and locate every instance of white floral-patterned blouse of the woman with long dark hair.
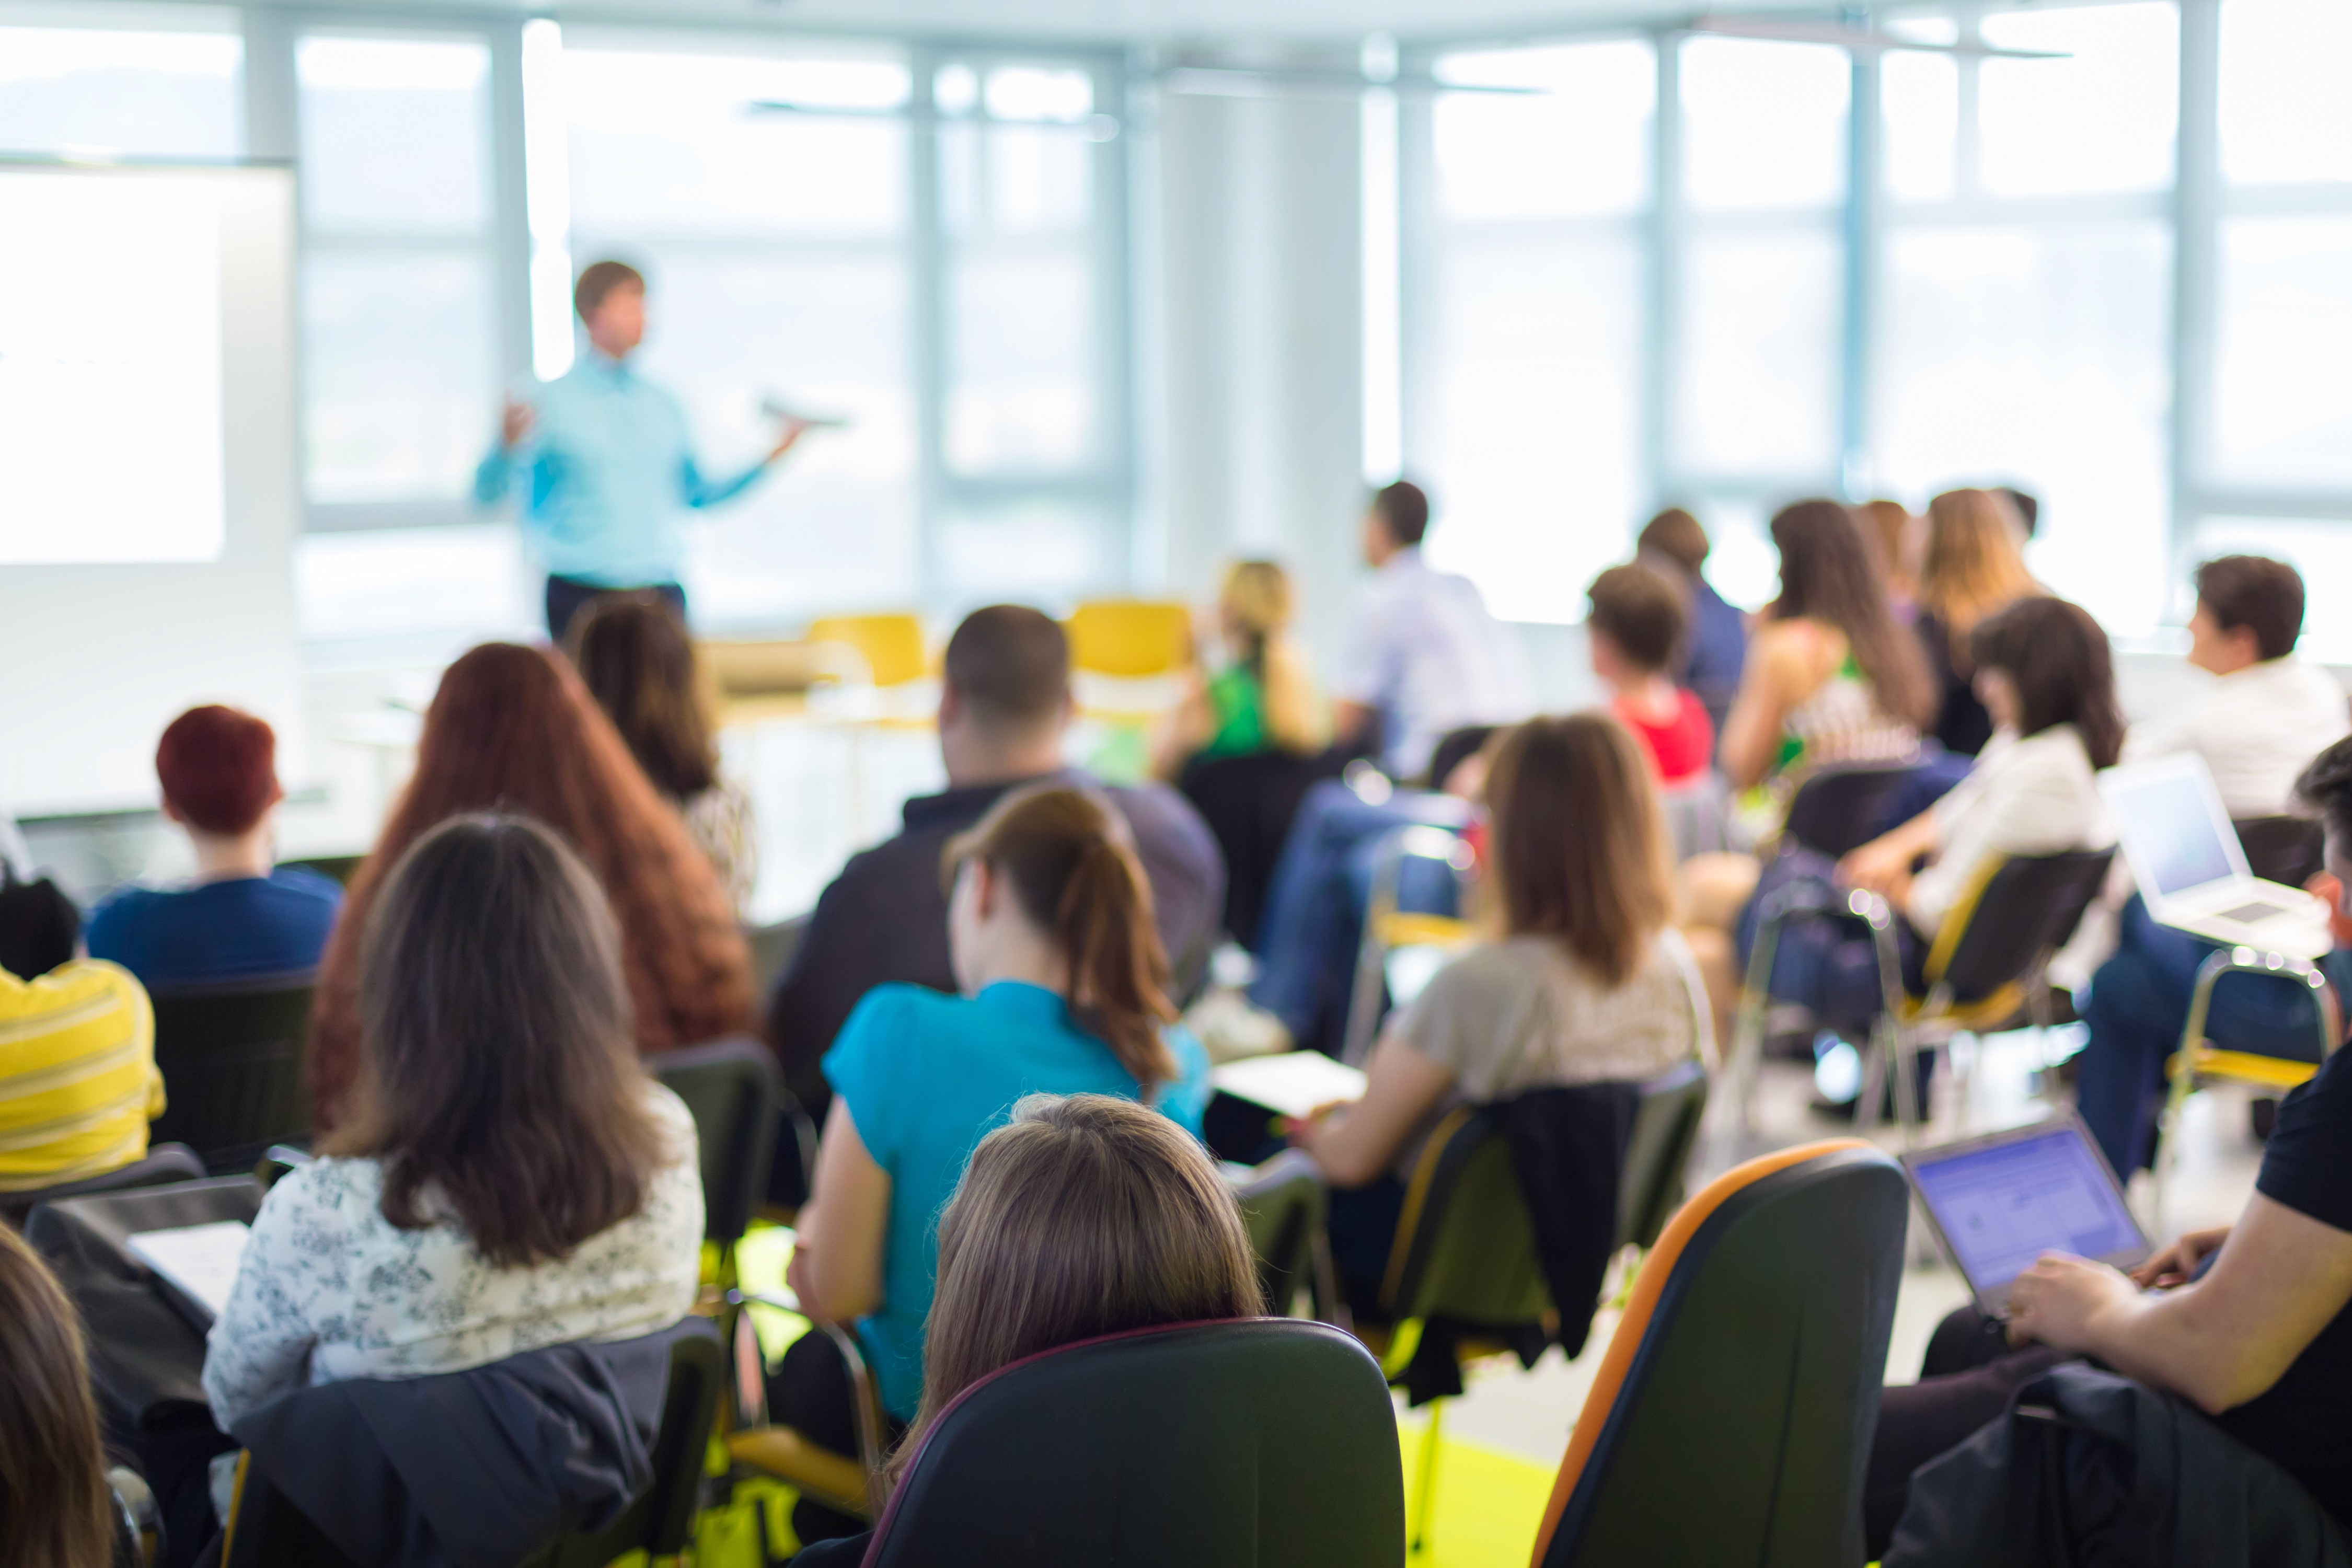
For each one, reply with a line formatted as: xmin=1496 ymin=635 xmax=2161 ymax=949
xmin=205 ymin=1083 xmax=704 ymax=1432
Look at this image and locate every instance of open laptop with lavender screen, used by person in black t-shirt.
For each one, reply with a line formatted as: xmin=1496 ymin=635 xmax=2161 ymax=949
xmin=1903 ymin=1114 xmax=2150 ymax=1317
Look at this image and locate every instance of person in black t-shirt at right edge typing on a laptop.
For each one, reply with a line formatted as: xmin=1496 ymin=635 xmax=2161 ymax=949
xmin=1867 ymin=741 xmax=2352 ymax=1557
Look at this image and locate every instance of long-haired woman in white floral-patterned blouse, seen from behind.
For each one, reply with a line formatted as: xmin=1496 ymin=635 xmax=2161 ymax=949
xmin=205 ymin=816 xmax=704 ymax=1432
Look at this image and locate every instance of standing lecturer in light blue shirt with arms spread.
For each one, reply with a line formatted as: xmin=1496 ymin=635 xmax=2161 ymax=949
xmin=473 ymin=261 xmax=809 ymax=647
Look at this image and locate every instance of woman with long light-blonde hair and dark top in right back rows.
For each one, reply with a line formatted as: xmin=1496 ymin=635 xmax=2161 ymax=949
xmin=1917 ymin=489 xmax=2042 ymax=757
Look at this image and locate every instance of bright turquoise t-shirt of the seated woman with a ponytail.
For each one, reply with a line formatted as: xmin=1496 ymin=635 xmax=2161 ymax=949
xmin=826 ymin=981 xmax=1209 ymax=1420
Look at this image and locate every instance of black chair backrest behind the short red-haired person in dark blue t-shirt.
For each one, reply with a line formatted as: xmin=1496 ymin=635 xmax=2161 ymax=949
xmin=148 ymin=971 xmax=313 ymax=1171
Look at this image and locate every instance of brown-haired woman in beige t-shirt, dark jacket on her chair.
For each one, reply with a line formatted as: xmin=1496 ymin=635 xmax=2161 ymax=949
xmin=1292 ymin=712 xmax=1708 ymax=1312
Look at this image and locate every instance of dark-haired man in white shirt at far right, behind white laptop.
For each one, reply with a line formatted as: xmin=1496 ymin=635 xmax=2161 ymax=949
xmin=2124 ymin=555 xmax=2352 ymax=818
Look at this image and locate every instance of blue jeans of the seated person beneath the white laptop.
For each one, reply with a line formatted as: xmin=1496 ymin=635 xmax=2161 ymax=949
xmin=2074 ymin=896 xmax=2347 ymax=1180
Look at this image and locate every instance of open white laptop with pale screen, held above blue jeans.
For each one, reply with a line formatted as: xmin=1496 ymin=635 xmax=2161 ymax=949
xmin=2098 ymin=752 xmax=2333 ymax=959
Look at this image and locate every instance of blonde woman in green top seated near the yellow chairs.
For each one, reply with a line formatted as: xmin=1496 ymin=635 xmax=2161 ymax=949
xmin=1152 ymin=562 xmax=1331 ymax=778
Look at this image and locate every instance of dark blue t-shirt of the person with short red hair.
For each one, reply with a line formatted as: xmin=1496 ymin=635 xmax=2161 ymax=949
xmin=85 ymin=868 xmax=343 ymax=987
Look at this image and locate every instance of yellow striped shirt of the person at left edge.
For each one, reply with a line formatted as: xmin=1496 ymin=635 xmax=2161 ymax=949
xmin=0 ymin=959 xmax=163 ymax=1192
